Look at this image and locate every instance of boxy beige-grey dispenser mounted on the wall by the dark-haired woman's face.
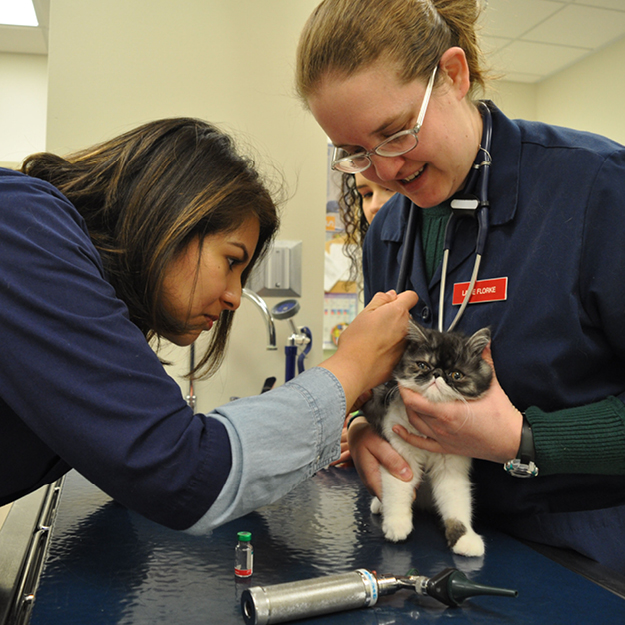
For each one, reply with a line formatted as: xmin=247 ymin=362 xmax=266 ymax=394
xmin=247 ymin=241 xmax=302 ymax=297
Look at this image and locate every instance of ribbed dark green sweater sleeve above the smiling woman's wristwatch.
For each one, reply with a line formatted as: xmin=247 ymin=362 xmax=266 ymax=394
xmin=525 ymin=397 xmax=625 ymax=475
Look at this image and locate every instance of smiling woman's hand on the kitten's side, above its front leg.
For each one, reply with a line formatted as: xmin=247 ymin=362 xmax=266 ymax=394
xmin=347 ymin=417 xmax=412 ymax=497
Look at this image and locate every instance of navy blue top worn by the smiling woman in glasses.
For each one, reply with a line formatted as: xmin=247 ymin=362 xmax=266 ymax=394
xmin=363 ymin=105 xmax=625 ymax=519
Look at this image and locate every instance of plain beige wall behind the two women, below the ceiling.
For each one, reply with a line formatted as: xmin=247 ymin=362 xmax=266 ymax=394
xmin=8 ymin=0 xmax=625 ymax=410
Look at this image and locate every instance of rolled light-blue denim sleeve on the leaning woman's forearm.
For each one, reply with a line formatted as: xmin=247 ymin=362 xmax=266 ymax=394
xmin=186 ymin=367 xmax=346 ymax=534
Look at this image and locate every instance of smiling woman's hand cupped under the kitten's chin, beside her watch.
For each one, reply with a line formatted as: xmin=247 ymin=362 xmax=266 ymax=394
xmin=393 ymin=346 xmax=523 ymax=463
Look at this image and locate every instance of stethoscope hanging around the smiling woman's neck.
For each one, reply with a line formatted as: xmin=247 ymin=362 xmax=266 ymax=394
xmin=396 ymin=102 xmax=493 ymax=332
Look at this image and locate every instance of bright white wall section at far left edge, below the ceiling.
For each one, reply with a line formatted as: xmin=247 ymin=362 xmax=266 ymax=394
xmin=0 ymin=52 xmax=48 ymax=165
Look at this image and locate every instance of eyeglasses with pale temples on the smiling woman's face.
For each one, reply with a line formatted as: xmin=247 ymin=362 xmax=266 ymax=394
xmin=332 ymin=65 xmax=438 ymax=174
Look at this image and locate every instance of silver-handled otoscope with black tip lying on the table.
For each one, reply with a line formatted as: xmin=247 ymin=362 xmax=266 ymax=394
xmin=241 ymin=568 xmax=518 ymax=625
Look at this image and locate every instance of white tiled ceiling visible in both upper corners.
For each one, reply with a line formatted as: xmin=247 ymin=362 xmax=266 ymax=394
xmin=0 ymin=0 xmax=625 ymax=83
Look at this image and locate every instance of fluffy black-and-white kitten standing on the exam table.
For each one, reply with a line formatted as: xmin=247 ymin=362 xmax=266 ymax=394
xmin=362 ymin=322 xmax=493 ymax=556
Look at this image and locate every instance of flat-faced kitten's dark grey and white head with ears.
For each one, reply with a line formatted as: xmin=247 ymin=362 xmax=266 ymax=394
xmin=394 ymin=324 xmax=492 ymax=402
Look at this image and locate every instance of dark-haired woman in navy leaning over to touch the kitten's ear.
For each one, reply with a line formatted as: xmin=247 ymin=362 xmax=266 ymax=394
xmin=0 ymin=118 xmax=416 ymax=532
